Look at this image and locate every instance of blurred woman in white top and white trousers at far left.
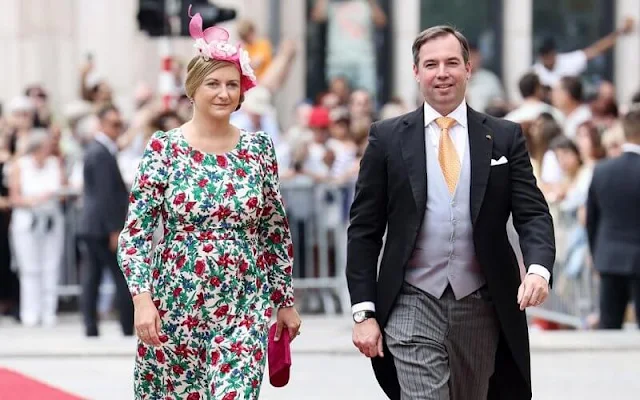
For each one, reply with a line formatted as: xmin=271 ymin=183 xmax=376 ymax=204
xmin=9 ymin=129 xmax=64 ymax=326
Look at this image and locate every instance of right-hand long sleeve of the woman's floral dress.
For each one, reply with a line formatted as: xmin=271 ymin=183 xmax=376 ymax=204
xmin=260 ymin=132 xmax=294 ymax=308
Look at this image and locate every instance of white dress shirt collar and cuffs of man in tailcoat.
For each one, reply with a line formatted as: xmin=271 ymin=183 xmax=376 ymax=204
xmin=351 ymin=101 xmax=551 ymax=313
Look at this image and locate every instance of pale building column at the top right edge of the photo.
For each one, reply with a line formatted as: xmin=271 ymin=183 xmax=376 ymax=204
xmin=614 ymin=0 xmax=640 ymax=104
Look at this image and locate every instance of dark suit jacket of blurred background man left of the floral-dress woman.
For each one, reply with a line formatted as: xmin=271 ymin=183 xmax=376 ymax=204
xmin=78 ymin=140 xmax=129 ymax=238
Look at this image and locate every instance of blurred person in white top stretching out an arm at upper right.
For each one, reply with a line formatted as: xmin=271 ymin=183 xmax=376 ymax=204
xmin=533 ymin=18 xmax=634 ymax=87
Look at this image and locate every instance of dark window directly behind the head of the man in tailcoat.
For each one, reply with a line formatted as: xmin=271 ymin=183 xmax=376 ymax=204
xmin=420 ymin=0 xmax=504 ymax=77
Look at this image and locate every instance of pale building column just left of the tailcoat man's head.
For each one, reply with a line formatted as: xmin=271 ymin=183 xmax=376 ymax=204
xmin=392 ymin=0 xmax=420 ymax=109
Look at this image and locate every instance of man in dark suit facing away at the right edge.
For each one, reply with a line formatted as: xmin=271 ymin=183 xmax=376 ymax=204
xmin=587 ymin=105 xmax=640 ymax=329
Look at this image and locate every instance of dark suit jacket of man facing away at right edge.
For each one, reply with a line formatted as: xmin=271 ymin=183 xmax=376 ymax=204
xmin=587 ymin=152 xmax=640 ymax=277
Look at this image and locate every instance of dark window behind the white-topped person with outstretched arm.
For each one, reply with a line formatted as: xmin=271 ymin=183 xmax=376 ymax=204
xmin=533 ymin=0 xmax=614 ymax=84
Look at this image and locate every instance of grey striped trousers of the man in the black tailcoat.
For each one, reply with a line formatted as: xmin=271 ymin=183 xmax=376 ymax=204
xmin=385 ymin=283 xmax=500 ymax=400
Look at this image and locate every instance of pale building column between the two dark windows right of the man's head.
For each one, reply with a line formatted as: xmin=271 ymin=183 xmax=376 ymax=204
xmin=502 ymin=0 xmax=532 ymax=102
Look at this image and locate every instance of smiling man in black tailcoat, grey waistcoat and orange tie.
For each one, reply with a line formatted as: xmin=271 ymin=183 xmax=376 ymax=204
xmin=347 ymin=26 xmax=555 ymax=400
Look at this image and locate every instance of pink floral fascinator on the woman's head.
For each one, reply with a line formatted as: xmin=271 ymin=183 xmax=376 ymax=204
xmin=188 ymin=6 xmax=256 ymax=93
